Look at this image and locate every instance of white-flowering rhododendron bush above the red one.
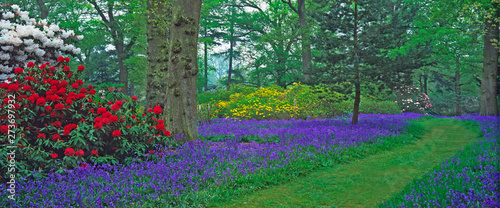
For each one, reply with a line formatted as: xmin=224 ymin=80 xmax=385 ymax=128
xmin=0 ymin=4 xmax=83 ymax=82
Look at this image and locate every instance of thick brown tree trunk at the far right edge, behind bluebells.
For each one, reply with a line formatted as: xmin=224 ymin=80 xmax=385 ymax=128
xmin=480 ymin=15 xmax=499 ymax=116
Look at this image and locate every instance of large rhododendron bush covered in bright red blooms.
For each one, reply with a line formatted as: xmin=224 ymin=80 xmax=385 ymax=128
xmin=0 ymin=57 xmax=171 ymax=181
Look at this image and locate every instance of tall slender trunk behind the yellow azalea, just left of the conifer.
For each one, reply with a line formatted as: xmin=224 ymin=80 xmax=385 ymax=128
xmin=297 ymin=0 xmax=312 ymax=83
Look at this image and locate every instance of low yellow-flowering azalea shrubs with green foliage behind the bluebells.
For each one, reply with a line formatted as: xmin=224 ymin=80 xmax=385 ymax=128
xmin=198 ymin=83 xmax=400 ymax=120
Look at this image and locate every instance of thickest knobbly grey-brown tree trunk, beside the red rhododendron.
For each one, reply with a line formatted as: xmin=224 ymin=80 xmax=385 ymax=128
xmin=164 ymin=0 xmax=201 ymax=141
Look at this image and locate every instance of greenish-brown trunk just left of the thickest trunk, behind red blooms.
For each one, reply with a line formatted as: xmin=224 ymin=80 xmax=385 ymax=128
xmin=145 ymin=0 xmax=172 ymax=110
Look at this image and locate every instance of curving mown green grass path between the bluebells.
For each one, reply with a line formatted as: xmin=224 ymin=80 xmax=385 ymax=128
xmin=213 ymin=118 xmax=477 ymax=207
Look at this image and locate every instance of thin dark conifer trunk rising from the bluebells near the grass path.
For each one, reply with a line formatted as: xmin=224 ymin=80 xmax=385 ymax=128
xmin=351 ymin=0 xmax=361 ymax=124
